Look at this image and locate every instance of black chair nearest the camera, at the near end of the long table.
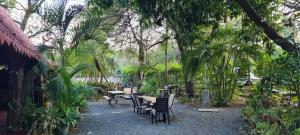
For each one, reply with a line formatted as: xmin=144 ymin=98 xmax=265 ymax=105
xmin=151 ymin=98 xmax=170 ymax=124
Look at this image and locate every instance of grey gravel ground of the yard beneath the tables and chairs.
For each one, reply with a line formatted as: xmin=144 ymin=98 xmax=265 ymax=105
xmin=71 ymin=101 xmax=242 ymax=135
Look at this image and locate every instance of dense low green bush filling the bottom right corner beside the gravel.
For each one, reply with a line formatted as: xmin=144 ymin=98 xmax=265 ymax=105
xmin=242 ymin=93 xmax=300 ymax=135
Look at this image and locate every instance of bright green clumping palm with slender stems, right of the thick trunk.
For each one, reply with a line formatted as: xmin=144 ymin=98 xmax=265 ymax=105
xmin=182 ymin=24 xmax=261 ymax=106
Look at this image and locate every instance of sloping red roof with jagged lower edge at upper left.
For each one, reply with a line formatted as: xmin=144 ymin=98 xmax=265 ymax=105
xmin=0 ymin=6 xmax=41 ymax=60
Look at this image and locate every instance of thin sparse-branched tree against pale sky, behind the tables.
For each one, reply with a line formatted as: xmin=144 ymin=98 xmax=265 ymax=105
xmin=105 ymin=9 xmax=170 ymax=89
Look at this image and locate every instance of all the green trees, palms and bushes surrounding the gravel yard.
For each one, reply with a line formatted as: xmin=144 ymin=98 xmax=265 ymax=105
xmin=0 ymin=0 xmax=300 ymax=134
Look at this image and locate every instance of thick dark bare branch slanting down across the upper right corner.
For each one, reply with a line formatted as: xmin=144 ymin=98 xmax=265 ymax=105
xmin=236 ymin=0 xmax=299 ymax=53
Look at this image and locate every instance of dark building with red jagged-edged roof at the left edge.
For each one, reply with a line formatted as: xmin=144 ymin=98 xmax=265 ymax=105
xmin=0 ymin=6 xmax=41 ymax=131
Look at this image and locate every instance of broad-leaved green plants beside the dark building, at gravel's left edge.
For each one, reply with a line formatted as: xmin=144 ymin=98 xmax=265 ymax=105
xmin=37 ymin=68 xmax=93 ymax=135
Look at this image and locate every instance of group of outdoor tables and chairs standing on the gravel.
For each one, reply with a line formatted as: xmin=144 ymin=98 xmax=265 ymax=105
xmin=103 ymin=87 xmax=175 ymax=124
